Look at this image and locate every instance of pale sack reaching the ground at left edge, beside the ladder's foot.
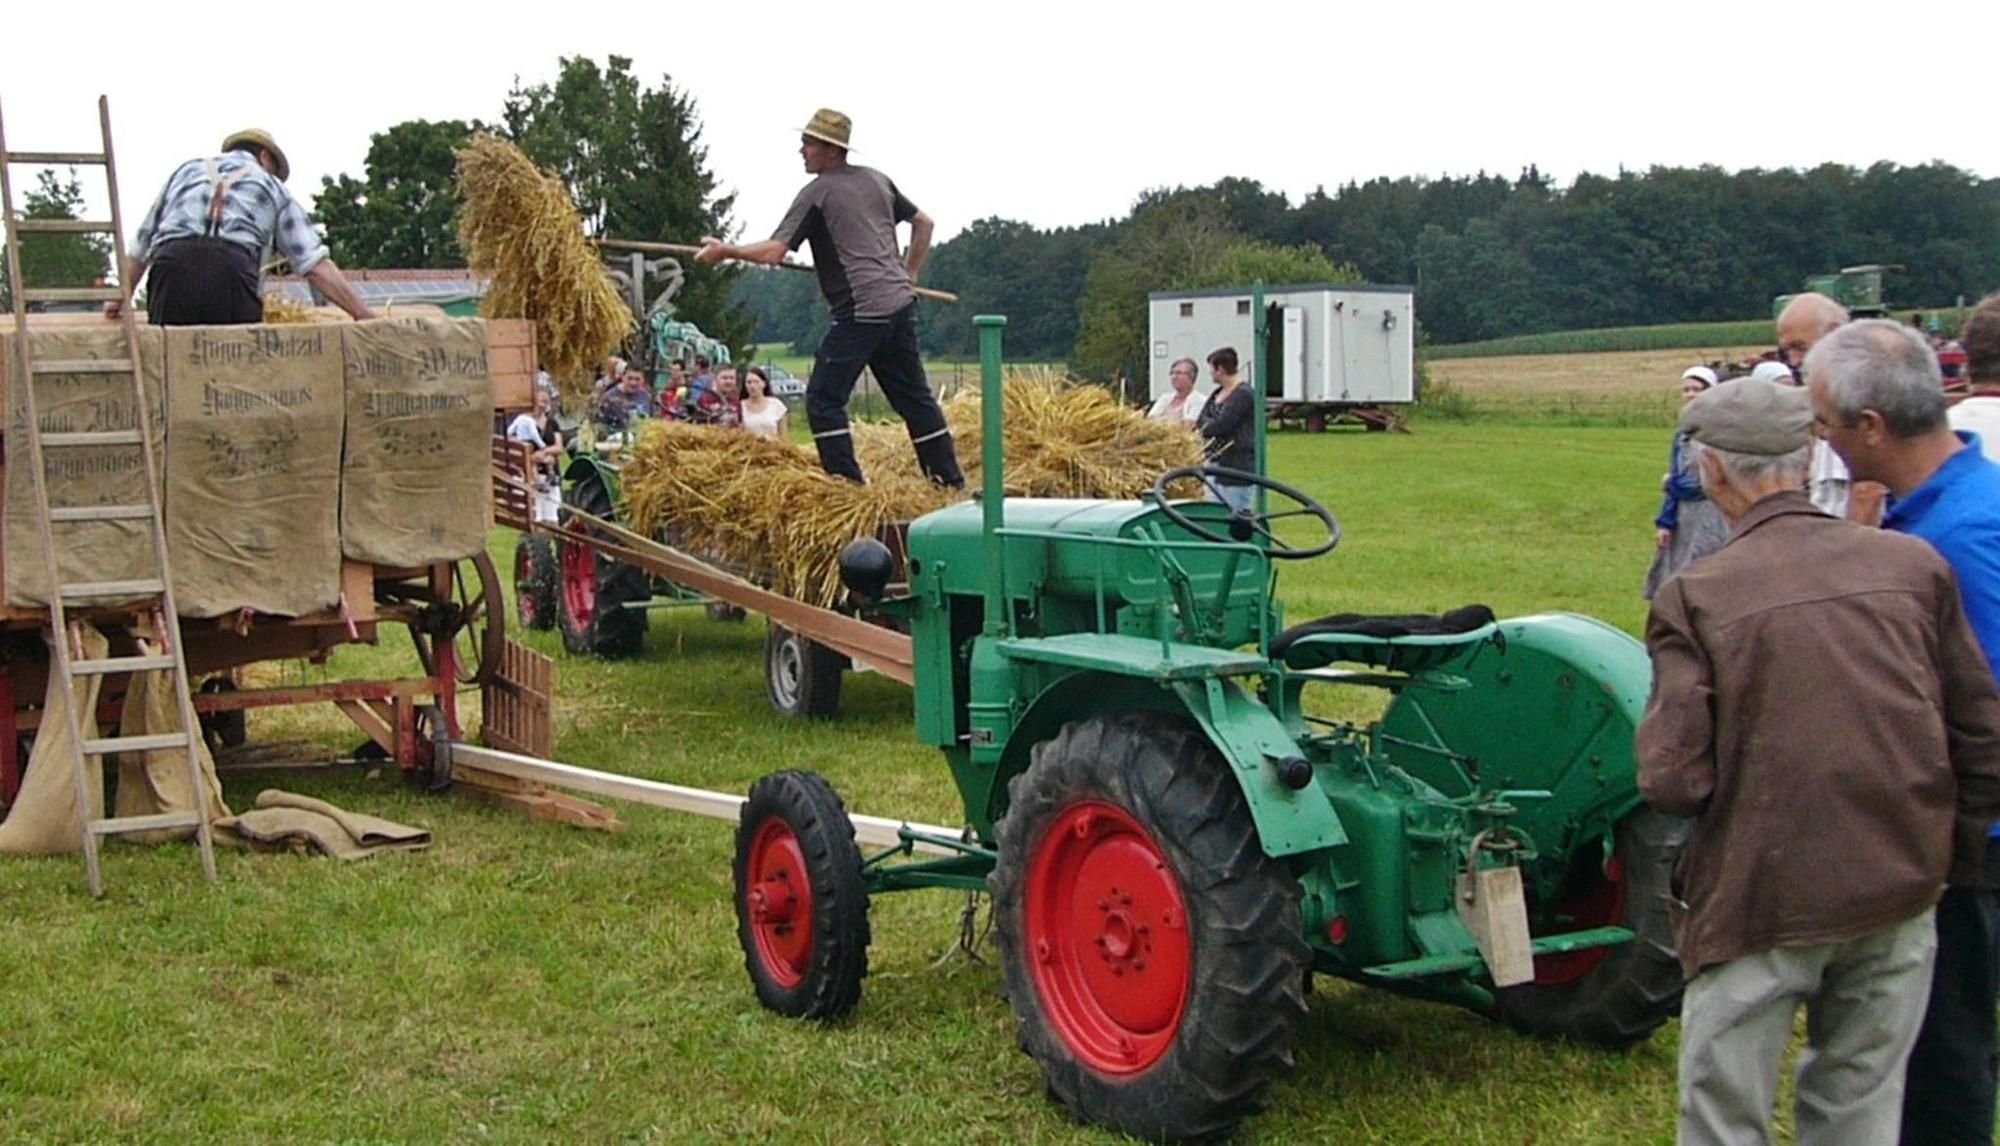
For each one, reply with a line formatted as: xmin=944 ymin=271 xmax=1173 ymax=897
xmin=0 ymin=624 xmax=110 ymax=856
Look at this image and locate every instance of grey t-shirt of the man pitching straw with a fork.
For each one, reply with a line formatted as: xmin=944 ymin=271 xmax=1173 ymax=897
xmin=772 ymin=164 xmax=916 ymax=322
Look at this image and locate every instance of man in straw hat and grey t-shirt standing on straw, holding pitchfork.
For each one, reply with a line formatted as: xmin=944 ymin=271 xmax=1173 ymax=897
xmin=694 ymin=108 xmax=966 ymax=486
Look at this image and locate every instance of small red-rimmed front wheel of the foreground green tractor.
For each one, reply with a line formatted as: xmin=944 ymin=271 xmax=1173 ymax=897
xmin=736 ymin=770 xmax=868 ymax=1018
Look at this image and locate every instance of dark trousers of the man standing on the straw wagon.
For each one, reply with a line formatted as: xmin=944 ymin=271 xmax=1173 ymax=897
xmin=806 ymin=302 xmax=966 ymax=486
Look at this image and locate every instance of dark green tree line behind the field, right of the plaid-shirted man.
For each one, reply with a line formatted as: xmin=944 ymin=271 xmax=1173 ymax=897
xmin=290 ymin=56 xmax=2000 ymax=376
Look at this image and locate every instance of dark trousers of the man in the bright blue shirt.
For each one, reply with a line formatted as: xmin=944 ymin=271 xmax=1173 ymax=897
xmin=1902 ymin=842 xmax=2000 ymax=1146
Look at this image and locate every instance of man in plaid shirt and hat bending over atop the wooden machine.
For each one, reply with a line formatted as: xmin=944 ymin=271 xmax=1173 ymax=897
xmin=108 ymin=128 xmax=374 ymax=326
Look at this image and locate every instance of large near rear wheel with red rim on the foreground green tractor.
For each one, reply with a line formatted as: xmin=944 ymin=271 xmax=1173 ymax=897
xmin=988 ymin=714 xmax=1308 ymax=1140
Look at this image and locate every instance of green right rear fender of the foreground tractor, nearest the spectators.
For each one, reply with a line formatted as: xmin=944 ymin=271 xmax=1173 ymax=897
xmin=1382 ymin=612 xmax=1652 ymax=852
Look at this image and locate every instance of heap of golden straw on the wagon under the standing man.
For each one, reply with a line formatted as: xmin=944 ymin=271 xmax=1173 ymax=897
xmin=620 ymin=372 xmax=1200 ymax=606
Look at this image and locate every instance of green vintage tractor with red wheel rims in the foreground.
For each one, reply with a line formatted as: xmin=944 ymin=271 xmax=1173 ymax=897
xmin=734 ymin=308 xmax=1684 ymax=1138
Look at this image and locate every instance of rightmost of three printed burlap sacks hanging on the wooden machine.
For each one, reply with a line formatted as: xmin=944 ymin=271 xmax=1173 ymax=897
xmin=340 ymin=318 xmax=492 ymax=566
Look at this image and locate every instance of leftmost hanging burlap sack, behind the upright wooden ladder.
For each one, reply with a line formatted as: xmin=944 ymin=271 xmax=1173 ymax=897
xmin=0 ymin=324 xmax=166 ymax=606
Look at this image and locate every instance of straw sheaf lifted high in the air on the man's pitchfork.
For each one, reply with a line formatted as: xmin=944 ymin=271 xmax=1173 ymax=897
xmin=456 ymin=134 xmax=632 ymax=398
